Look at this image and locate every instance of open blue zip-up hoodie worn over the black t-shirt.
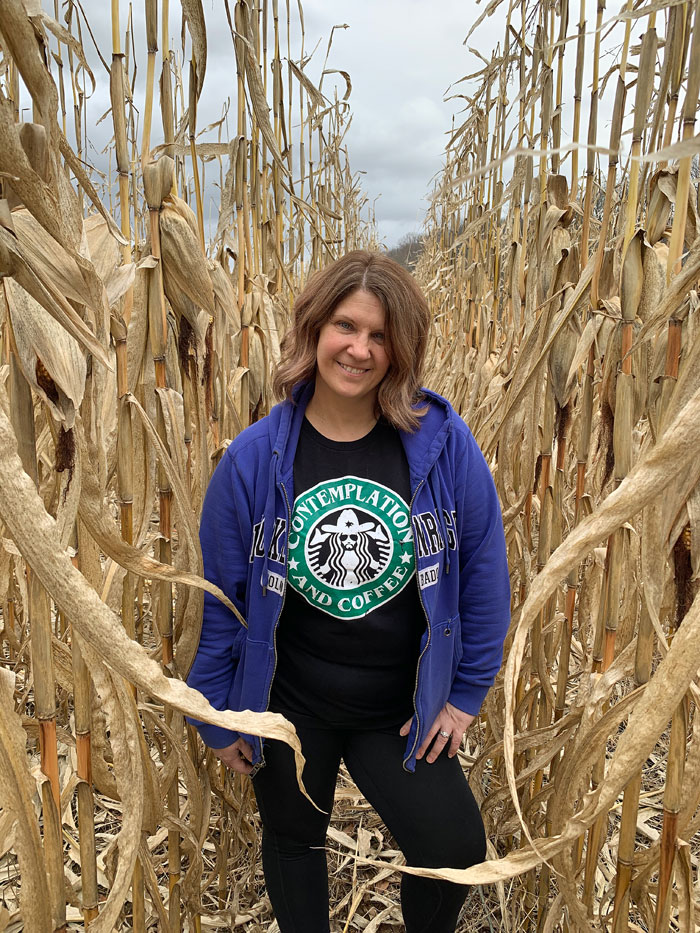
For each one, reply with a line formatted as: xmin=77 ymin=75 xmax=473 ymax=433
xmin=187 ymin=383 xmax=510 ymax=771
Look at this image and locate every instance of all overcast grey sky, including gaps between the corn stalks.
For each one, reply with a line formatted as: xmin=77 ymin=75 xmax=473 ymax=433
xmin=43 ymin=0 xmax=636 ymax=247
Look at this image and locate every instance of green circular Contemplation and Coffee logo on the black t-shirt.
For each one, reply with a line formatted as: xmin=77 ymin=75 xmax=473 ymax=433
xmin=287 ymin=476 xmax=416 ymax=619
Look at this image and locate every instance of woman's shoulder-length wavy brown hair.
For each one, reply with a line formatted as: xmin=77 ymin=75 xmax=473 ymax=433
xmin=273 ymin=249 xmax=430 ymax=431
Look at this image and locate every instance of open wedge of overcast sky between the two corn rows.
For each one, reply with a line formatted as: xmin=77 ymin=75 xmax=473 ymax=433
xmin=294 ymin=0 xmax=503 ymax=247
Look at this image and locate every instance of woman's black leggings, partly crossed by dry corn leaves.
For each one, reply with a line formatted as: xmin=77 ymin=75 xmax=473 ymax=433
xmin=253 ymin=725 xmax=486 ymax=933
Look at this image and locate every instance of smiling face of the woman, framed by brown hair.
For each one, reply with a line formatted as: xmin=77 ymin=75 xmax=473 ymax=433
xmin=316 ymin=291 xmax=390 ymax=403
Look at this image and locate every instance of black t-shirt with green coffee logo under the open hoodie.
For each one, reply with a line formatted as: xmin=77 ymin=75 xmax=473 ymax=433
xmin=270 ymin=419 xmax=425 ymax=728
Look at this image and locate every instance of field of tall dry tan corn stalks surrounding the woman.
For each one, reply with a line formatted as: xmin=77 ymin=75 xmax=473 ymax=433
xmin=0 ymin=0 xmax=700 ymax=933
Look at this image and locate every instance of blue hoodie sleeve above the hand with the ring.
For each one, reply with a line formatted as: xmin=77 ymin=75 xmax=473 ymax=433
xmin=449 ymin=419 xmax=510 ymax=716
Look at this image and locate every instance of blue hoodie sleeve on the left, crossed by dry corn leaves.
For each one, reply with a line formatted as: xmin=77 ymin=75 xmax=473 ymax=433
xmin=187 ymin=452 xmax=248 ymax=748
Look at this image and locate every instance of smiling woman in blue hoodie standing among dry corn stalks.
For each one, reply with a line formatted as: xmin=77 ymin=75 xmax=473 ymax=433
xmin=188 ymin=251 xmax=509 ymax=933
